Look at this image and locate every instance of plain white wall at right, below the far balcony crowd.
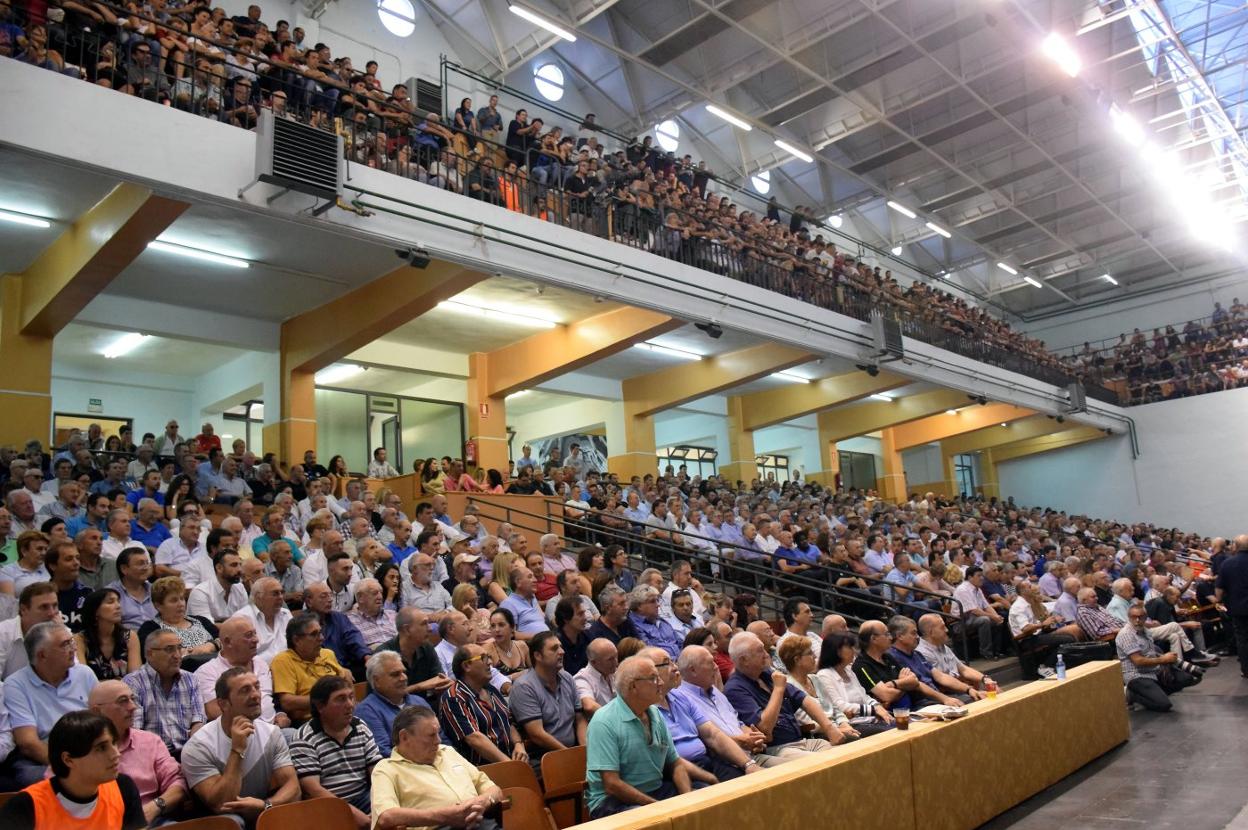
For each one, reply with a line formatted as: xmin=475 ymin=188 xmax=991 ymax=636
xmin=997 ymin=389 xmax=1248 ymax=535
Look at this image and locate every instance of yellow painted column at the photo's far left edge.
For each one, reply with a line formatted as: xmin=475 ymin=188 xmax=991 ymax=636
xmin=0 ymin=275 xmax=52 ymax=449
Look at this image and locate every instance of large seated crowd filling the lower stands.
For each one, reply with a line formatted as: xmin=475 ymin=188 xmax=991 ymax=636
xmin=0 ymin=422 xmax=1248 ymax=828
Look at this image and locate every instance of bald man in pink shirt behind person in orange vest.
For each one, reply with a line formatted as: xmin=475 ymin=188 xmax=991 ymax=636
xmin=87 ymin=680 xmax=187 ymax=824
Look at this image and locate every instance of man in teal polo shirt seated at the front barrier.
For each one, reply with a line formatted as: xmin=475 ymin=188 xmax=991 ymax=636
xmin=585 ymin=655 xmax=693 ymax=819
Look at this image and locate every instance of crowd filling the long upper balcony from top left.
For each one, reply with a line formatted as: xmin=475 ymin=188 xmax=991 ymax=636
xmin=0 ymin=0 xmax=1113 ymax=394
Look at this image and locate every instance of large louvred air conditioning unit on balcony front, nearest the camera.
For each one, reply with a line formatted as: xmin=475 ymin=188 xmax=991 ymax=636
xmin=256 ymin=110 xmax=346 ymax=207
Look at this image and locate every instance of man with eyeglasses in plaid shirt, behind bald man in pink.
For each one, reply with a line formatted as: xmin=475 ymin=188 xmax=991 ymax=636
xmin=122 ymin=629 xmax=205 ymax=758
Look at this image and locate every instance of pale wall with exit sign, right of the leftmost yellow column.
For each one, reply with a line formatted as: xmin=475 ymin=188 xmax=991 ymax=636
xmin=52 ymin=361 xmax=200 ymax=442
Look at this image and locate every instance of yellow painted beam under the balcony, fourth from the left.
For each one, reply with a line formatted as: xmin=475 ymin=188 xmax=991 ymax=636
xmin=623 ymin=343 xmax=816 ymax=416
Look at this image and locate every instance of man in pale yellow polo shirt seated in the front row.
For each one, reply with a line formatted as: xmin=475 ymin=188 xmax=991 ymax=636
xmin=372 ymin=705 xmax=503 ymax=830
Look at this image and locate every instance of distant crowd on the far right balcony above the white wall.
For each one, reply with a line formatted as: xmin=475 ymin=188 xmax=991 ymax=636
xmin=1067 ymin=297 xmax=1248 ymax=404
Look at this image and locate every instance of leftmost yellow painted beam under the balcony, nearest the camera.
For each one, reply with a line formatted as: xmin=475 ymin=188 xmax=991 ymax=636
xmin=21 ymin=182 xmax=190 ymax=337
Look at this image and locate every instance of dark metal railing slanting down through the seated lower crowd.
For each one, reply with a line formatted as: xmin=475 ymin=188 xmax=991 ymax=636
xmin=468 ymin=496 xmax=968 ymax=655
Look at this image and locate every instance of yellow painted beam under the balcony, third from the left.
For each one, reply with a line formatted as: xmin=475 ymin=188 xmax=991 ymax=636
xmin=488 ymin=307 xmax=684 ymax=398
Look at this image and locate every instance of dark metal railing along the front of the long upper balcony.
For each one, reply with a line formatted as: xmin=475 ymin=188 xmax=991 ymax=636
xmin=4 ymin=8 xmax=1118 ymax=403
